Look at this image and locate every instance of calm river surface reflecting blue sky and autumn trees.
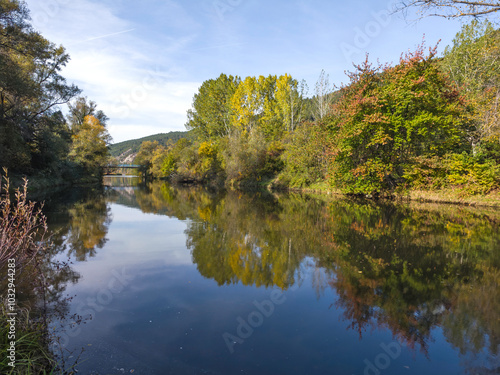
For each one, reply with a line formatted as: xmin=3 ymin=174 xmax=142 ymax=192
xmin=43 ymin=178 xmax=500 ymax=375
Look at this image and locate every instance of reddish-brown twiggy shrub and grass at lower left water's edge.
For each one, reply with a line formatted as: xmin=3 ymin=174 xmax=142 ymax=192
xmin=0 ymin=177 xmax=55 ymax=374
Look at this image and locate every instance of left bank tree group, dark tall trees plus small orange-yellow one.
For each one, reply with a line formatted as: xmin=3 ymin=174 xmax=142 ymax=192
xmin=0 ymin=0 xmax=111 ymax=186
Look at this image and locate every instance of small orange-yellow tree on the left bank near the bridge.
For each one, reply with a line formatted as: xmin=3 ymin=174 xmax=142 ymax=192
xmin=69 ymin=115 xmax=111 ymax=176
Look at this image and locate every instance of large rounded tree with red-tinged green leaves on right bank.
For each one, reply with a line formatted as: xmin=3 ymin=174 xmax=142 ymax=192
xmin=328 ymin=47 xmax=469 ymax=194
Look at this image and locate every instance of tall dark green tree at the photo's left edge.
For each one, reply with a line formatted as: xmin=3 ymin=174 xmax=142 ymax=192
xmin=0 ymin=0 xmax=80 ymax=172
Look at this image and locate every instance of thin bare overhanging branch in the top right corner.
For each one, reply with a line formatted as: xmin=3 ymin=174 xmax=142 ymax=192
xmin=396 ymin=0 xmax=500 ymax=18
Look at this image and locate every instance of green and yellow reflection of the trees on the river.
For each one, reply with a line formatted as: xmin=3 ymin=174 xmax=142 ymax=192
xmin=45 ymin=183 xmax=500 ymax=373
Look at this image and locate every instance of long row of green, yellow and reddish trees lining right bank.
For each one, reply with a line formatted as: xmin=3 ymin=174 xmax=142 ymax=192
xmin=136 ymin=20 xmax=500 ymax=195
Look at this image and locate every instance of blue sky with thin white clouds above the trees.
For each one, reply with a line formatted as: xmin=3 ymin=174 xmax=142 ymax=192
xmin=26 ymin=0 xmax=461 ymax=142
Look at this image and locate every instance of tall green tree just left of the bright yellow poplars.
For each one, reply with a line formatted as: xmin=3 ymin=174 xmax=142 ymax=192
xmin=186 ymin=74 xmax=240 ymax=140
